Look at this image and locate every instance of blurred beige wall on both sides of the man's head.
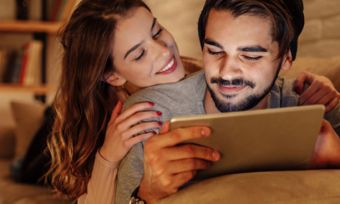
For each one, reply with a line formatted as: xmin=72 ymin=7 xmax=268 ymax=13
xmin=145 ymin=0 xmax=340 ymax=58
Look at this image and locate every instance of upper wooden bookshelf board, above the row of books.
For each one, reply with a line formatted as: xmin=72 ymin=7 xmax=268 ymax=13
xmin=0 ymin=20 xmax=62 ymax=34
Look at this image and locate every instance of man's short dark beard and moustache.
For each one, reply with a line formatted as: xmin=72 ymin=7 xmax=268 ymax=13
xmin=208 ymin=62 xmax=282 ymax=112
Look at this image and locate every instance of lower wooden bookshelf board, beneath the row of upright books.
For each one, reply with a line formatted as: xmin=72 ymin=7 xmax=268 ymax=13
xmin=0 ymin=84 xmax=50 ymax=94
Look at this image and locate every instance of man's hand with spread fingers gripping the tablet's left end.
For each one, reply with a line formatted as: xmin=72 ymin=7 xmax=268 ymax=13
xmin=138 ymin=122 xmax=220 ymax=203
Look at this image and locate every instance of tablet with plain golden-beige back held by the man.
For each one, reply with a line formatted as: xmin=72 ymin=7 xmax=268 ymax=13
xmin=170 ymin=105 xmax=325 ymax=179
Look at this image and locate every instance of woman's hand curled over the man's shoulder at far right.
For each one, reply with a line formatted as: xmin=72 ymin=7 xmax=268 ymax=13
xmin=294 ymin=72 xmax=340 ymax=112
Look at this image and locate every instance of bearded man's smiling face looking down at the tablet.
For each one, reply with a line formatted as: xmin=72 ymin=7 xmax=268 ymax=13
xmin=203 ymin=10 xmax=287 ymax=112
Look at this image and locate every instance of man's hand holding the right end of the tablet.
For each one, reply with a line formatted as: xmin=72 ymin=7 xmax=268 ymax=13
xmin=312 ymin=120 xmax=340 ymax=167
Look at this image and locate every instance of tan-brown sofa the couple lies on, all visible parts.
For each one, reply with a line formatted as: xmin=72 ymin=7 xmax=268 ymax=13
xmin=0 ymin=57 xmax=340 ymax=204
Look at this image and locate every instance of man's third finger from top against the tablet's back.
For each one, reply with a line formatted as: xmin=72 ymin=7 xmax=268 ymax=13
xmin=168 ymin=159 xmax=211 ymax=174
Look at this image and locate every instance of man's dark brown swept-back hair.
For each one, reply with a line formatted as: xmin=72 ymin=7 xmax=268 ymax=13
xmin=198 ymin=0 xmax=304 ymax=59
